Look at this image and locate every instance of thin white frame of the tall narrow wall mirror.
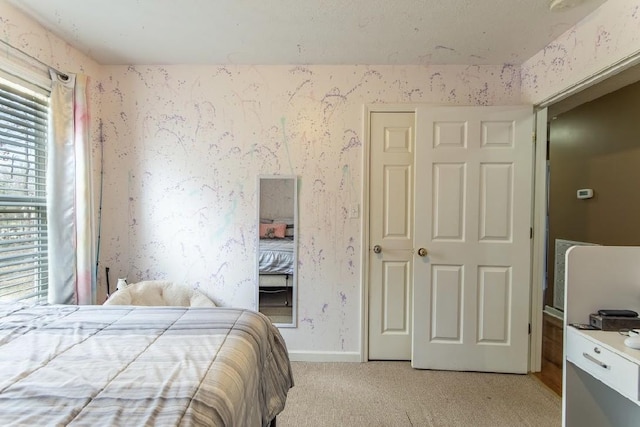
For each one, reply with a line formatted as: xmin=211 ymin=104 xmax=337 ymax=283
xmin=255 ymin=175 xmax=299 ymax=328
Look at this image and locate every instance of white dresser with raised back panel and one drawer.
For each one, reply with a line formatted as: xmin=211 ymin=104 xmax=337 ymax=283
xmin=563 ymin=246 xmax=640 ymax=427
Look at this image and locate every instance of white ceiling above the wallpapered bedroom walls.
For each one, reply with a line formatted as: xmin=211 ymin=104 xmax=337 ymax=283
xmin=8 ymin=0 xmax=605 ymax=65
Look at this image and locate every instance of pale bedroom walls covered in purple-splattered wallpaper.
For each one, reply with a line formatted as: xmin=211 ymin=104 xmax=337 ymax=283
xmin=0 ymin=1 xmax=640 ymax=354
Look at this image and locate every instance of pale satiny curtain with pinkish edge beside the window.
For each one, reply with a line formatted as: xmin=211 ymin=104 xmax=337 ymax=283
xmin=47 ymin=71 xmax=96 ymax=304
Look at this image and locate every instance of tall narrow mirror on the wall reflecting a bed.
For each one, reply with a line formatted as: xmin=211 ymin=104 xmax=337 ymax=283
xmin=256 ymin=175 xmax=298 ymax=327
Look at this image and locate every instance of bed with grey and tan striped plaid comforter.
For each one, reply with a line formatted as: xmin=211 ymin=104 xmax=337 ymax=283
xmin=0 ymin=304 xmax=293 ymax=426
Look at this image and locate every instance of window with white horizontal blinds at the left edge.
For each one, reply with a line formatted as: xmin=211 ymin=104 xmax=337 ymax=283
xmin=0 ymin=77 xmax=49 ymax=302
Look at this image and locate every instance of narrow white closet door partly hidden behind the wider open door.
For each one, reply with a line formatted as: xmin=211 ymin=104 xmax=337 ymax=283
xmin=368 ymin=112 xmax=415 ymax=360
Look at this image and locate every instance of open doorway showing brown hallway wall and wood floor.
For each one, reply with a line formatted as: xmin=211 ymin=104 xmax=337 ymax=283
xmin=538 ymin=72 xmax=640 ymax=394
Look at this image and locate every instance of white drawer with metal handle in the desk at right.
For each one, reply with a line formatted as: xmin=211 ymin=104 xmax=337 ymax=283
xmin=566 ymin=328 xmax=640 ymax=403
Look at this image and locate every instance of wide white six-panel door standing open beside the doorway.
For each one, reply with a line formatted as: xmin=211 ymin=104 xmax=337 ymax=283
xmin=412 ymin=107 xmax=533 ymax=373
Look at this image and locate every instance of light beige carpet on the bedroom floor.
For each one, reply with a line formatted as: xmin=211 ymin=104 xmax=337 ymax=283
xmin=277 ymin=362 xmax=562 ymax=427
